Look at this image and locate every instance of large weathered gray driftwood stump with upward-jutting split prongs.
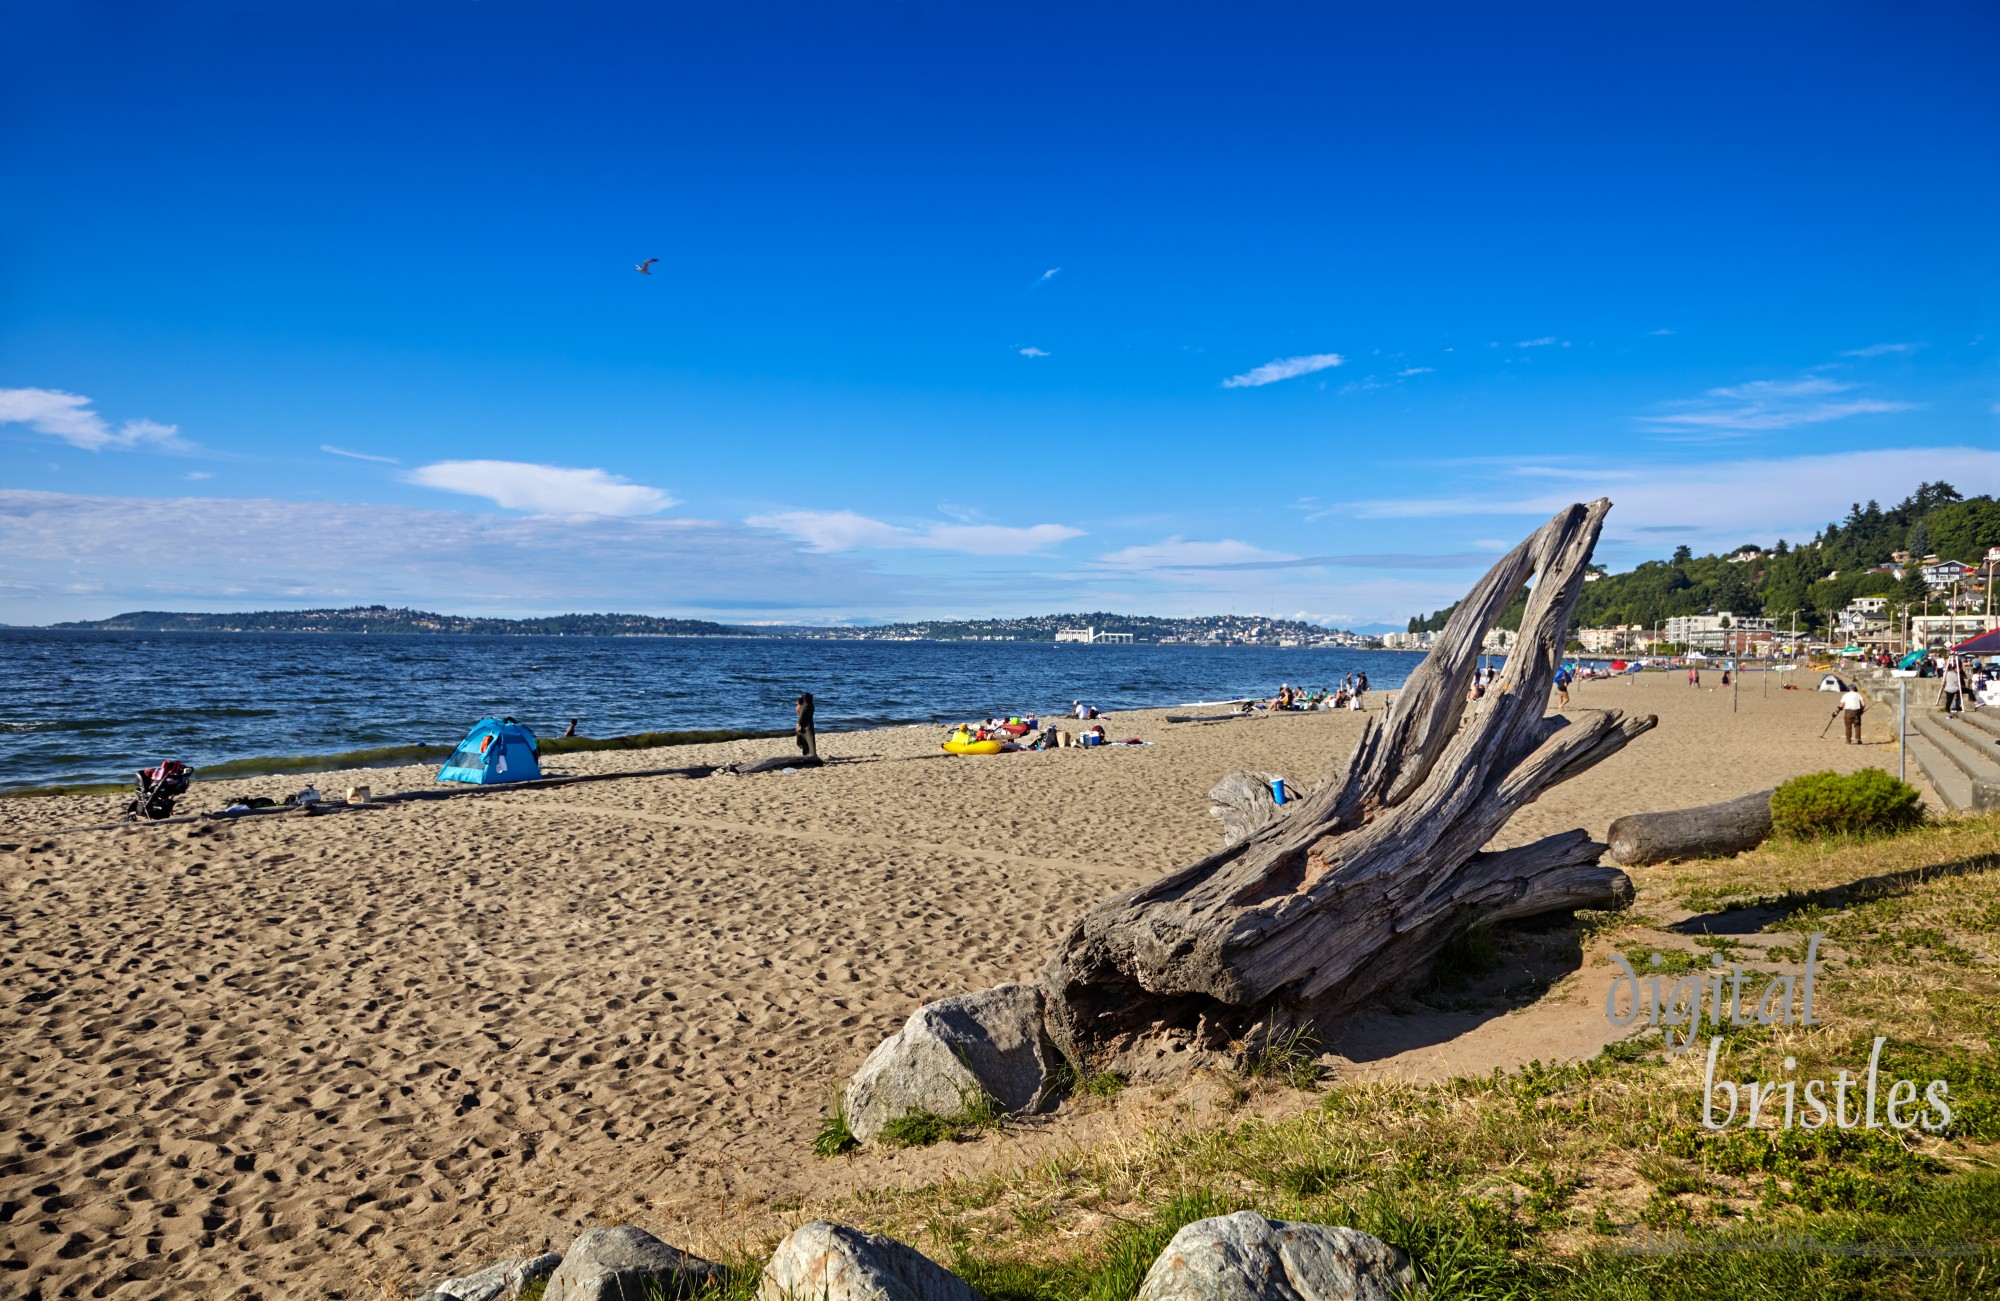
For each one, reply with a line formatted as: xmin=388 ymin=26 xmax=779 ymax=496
xmin=1042 ymin=500 xmax=1656 ymax=1061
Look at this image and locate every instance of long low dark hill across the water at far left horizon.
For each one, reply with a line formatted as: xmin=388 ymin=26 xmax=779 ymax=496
xmin=52 ymin=604 xmax=752 ymax=636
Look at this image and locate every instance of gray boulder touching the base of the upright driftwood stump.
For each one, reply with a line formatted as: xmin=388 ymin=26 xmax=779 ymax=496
xmin=846 ymin=985 xmax=1062 ymax=1143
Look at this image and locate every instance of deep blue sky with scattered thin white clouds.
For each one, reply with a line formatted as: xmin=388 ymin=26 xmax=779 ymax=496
xmin=0 ymin=0 xmax=2000 ymax=626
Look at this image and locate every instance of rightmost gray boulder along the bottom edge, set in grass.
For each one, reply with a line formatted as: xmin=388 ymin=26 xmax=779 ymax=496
xmin=1136 ymin=1211 xmax=1414 ymax=1301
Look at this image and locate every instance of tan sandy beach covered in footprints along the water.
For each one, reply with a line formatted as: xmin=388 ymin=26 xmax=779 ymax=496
xmin=0 ymin=675 xmax=1914 ymax=1299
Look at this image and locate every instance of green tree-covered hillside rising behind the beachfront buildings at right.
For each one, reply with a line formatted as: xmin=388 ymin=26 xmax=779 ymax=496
xmin=1410 ymin=482 xmax=2000 ymax=632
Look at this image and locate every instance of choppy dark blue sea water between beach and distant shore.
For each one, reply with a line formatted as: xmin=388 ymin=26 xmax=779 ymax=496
xmin=0 ymin=628 xmax=1422 ymax=791
